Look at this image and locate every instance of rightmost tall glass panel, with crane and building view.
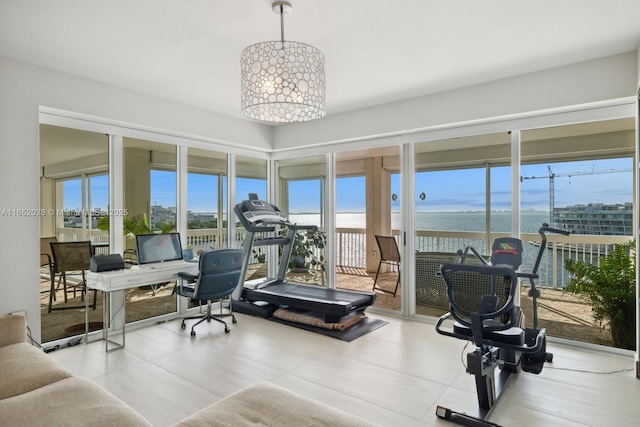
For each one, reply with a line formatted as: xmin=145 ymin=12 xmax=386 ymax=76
xmin=520 ymin=119 xmax=635 ymax=345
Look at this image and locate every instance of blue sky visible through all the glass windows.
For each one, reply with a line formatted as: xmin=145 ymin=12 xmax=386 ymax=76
xmin=64 ymin=158 xmax=633 ymax=213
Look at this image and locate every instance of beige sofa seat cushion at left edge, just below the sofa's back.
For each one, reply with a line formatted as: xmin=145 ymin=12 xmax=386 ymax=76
xmin=0 ymin=342 xmax=72 ymax=399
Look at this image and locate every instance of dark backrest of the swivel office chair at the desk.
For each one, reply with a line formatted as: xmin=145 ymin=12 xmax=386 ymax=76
xmin=193 ymin=249 xmax=242 ymax=301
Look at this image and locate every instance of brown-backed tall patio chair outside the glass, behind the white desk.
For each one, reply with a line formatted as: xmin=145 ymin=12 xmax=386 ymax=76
xmin=48 ymin=241 xmax=97 ymax=313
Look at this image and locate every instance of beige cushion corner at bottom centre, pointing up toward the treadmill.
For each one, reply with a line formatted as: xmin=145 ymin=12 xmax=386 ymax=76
xmin=174 ymin=381 xmax=376 ymax=427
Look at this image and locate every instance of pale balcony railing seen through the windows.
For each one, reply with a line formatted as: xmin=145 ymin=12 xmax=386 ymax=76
xmin=58 ymin=228 xmax=632 ymax=288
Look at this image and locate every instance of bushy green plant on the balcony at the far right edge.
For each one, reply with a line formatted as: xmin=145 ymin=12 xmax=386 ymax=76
xmin=565 ymin=240 xmax=636 ymax=350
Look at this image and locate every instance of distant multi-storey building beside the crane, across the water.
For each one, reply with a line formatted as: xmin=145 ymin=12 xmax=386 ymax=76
xmin=553 ymin=202 xmax=634 ymax=236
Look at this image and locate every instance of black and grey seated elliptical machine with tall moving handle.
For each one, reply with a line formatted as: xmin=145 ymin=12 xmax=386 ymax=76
xmin=436 ymin=223 xmax=569 ymax=426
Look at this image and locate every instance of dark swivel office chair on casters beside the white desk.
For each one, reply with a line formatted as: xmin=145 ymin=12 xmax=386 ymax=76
xmin=174 ymin=249 xmax=242 ymax=337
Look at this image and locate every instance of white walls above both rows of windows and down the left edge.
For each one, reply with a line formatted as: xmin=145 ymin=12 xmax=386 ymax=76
xmin=0 ymin=53 xmax=638 ymax=339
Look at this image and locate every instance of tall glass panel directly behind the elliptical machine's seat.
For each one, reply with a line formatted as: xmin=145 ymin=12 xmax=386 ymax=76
xmin=413 ymin=132 xmax=512 ymax=316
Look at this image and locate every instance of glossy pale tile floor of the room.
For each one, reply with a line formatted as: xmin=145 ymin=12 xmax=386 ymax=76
xmin=50 ymin=313 xmax=640 ymax=427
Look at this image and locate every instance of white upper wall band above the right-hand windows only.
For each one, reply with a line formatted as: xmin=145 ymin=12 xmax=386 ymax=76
xmin=274 ymin=52 xmax=638 ymax=150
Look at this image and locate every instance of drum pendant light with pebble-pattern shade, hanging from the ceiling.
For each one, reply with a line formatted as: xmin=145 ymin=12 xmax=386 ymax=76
xmin=240 ymin=2 xmax=325 ymax=123
